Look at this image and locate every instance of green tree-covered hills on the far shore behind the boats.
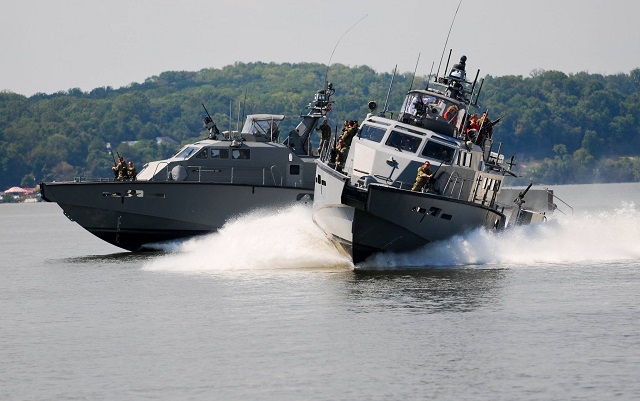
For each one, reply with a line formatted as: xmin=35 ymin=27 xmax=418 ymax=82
xmin=0 ymin=62 xmax=640 ymax=189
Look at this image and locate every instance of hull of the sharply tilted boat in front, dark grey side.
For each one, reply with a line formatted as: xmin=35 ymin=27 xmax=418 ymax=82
xmin=313 ymin=164 xmax=505 ymax=264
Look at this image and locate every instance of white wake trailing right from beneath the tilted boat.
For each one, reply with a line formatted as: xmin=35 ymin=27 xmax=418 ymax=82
xmin=358 ymin=203 xmax=640 ymax=269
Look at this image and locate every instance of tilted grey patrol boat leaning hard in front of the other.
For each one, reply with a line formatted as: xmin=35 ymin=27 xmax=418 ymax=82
xmin=313 ymin=56 xmax=554 ymax=264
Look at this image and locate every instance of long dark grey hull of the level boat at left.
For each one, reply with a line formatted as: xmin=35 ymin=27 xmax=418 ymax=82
xmin=41 ymin=181 xmax=313 ymax=251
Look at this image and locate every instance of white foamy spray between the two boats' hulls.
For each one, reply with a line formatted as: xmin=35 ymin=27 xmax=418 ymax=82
xmin=144 ymin=205 xmax=353 ymax=272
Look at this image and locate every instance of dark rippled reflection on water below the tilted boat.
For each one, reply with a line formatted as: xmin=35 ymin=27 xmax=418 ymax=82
xmin=348 ymin=268 xmax=506 ymax=313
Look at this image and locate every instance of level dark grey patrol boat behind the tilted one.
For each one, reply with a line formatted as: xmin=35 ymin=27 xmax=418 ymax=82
xmin=40 ymin=84 xmax=335 ymax=251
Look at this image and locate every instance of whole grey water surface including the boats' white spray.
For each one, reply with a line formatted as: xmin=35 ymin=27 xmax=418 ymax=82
xmin=0 ymin=184 xmax=640 ymax=400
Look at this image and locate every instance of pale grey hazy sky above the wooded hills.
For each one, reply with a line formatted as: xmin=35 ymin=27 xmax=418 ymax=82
xmin=0 ymin=0 xmax=640 ymax=96
